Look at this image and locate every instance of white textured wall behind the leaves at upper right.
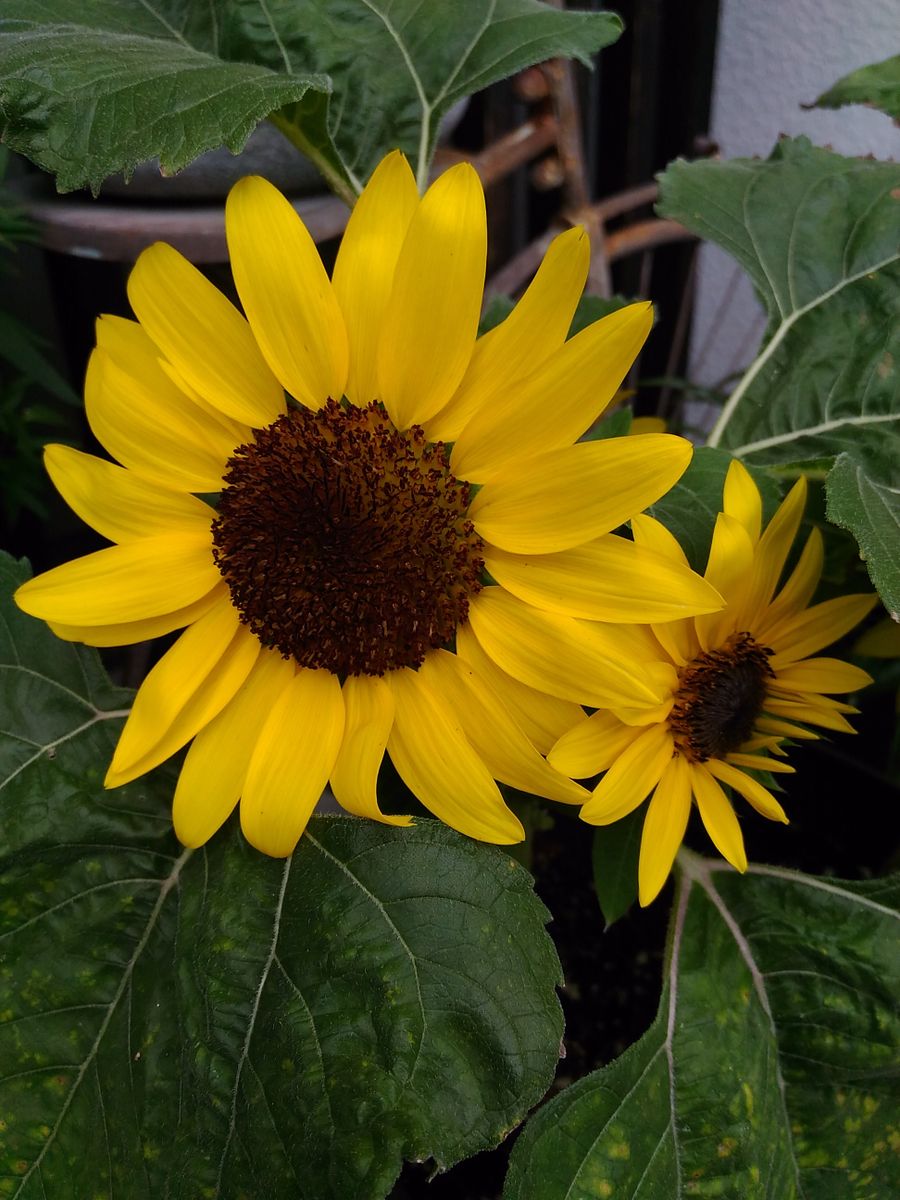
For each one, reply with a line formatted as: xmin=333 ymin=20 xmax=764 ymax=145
xmin=689 ymin=0 xmax=900 ymax=398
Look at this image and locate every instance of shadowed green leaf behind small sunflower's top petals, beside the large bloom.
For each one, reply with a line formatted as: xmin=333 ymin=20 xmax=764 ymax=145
xmin=647 ymin=446 xmax=781 ymax=572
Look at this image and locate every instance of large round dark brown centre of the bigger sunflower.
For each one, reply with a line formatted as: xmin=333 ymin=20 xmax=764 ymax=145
xmin=212 ymin=400 xmax=484 ymax=676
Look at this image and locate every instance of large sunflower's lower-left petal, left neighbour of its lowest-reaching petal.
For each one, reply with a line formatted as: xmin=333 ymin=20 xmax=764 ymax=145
xmin=172 ymin=650 xmax=295 ymax=847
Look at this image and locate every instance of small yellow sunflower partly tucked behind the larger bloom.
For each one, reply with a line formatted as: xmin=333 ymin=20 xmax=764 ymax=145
xmin=548 ymin=460 xmax=877 ymax=905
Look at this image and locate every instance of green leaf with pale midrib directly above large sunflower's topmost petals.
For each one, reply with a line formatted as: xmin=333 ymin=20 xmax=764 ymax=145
xmin=264 ymin=0 xmax=623 ymax=191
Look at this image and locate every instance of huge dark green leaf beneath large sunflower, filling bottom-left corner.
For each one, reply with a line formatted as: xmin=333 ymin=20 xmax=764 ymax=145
xmin=0 ymin=559 xmax=562 ymax=1200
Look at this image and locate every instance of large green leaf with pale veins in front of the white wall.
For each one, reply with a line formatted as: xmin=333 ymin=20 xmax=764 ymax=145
xmin=661 ymin=138 xmax=900 ymax=608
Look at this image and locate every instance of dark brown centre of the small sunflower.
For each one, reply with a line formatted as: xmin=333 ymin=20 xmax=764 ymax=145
xmin=668 ymin=634 xmax=775 ymax=762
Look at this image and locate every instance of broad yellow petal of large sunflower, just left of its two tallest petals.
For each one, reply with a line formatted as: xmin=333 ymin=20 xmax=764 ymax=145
xmin=226 ymin=175 xmax=348 ymax=408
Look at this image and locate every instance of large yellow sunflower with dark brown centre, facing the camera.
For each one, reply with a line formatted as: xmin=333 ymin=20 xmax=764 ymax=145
xmin=17 ymin=154 xmax=721 ymax=856
